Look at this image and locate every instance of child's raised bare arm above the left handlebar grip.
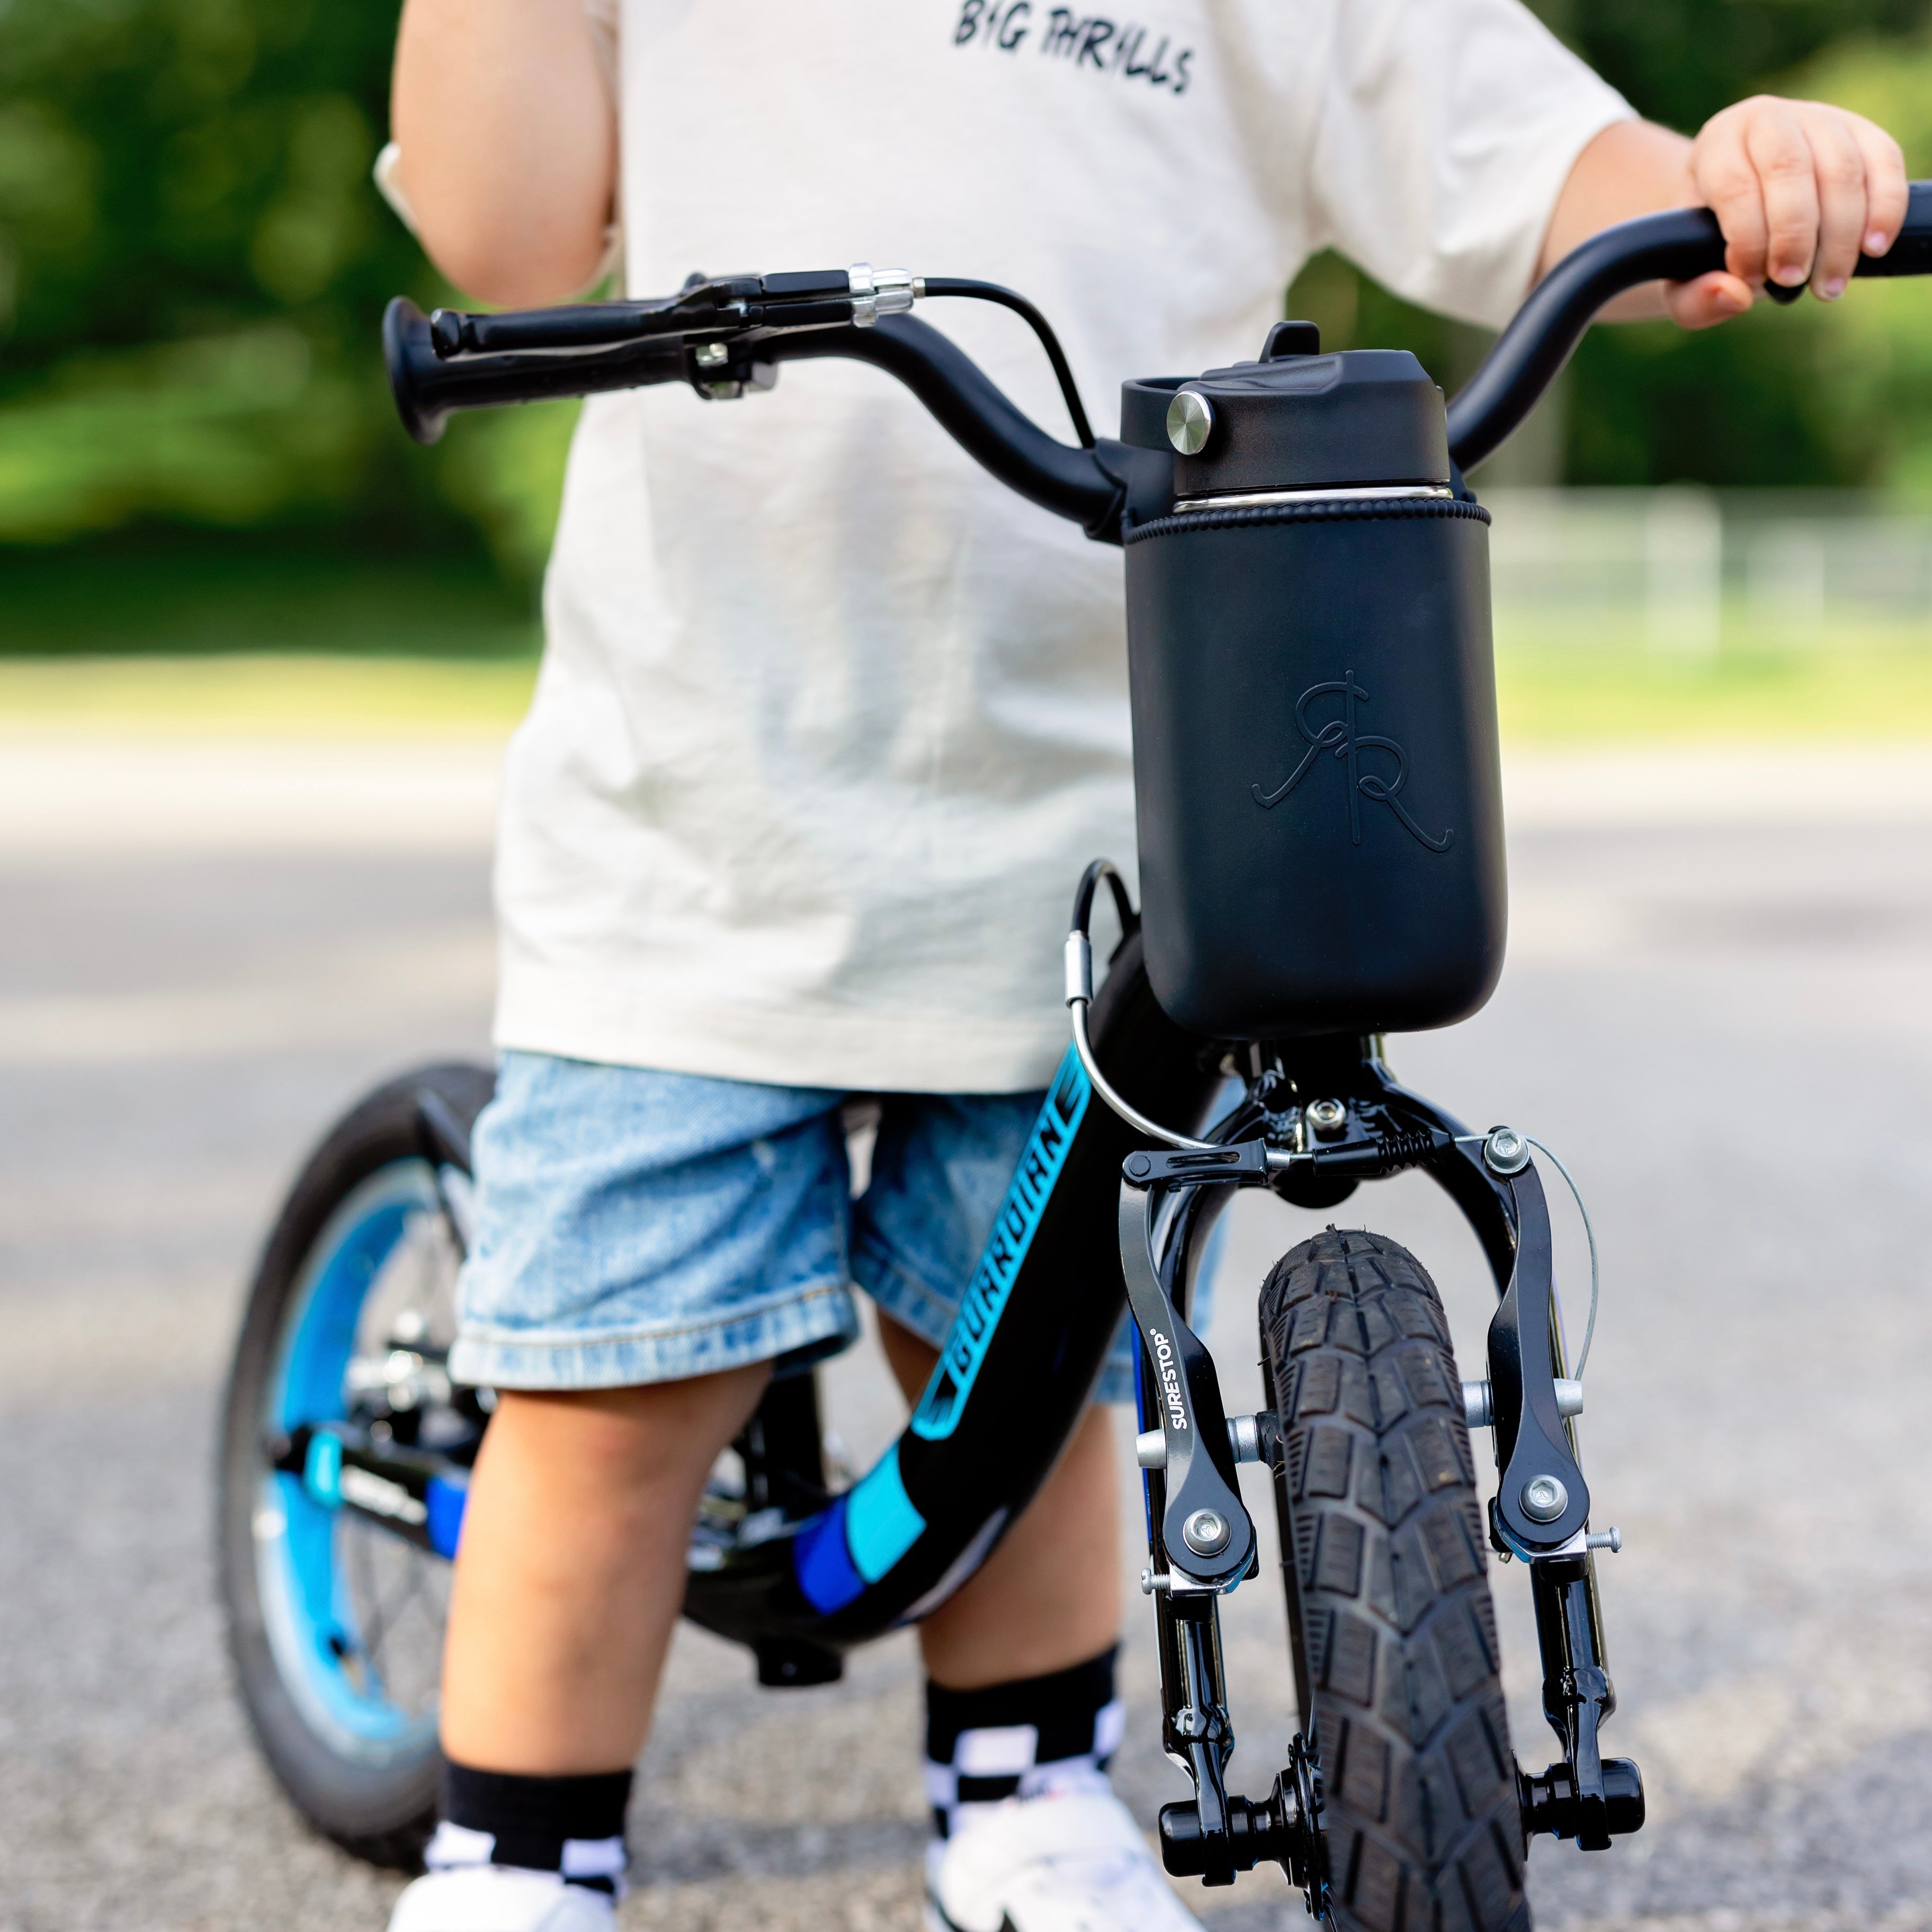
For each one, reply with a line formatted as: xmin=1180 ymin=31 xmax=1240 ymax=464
xmin=390 ymin=0 xmax=616 ymax=307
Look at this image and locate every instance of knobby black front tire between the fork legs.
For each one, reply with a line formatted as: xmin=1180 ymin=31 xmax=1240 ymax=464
xmin=1262 ymin=1227 xmax=1530 ymax=1932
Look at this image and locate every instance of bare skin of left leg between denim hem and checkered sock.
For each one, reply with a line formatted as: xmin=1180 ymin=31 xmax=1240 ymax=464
xmin=442 ymin=1362 xmax=769 ymax=1777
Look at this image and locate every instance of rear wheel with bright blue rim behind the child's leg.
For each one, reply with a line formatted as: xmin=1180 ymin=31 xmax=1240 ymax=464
xmin=218 ymin=1067 xmax=493 ymax=1866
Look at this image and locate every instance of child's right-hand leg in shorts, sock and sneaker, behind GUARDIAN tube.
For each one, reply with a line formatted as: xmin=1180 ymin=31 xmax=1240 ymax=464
xmin=854 ymin=1095 xmax=1200 ymax=1932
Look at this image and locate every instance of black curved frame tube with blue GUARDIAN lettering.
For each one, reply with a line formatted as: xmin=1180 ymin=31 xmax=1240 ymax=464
xmin=686 ymin=919 xmax=1225 ymax=1683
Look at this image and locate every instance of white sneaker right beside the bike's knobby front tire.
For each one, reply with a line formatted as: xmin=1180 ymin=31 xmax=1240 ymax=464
xmin=923 ymin=1791 xmax=1202 ymax=1932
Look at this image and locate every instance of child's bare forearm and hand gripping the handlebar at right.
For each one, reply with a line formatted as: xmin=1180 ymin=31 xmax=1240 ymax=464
xmin=1538 ymin=95 xmax=1905 ymax=328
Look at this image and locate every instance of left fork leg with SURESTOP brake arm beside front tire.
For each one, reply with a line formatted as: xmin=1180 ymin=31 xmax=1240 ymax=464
xmin=1121 ymin=1140 xmax=1327 ymax=1918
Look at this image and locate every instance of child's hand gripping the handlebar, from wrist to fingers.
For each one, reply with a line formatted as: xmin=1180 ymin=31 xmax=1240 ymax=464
xmin=1663 ymin=95 xmax=1905 ymax=328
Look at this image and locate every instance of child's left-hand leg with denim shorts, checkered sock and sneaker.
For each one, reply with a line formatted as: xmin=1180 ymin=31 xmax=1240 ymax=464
xmin=390 ymin=1053 xmax=858 ymax=1932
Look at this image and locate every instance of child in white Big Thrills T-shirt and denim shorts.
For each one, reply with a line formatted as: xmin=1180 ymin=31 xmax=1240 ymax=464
xmin=373 ymin=0 xmax=1905 ymax=1932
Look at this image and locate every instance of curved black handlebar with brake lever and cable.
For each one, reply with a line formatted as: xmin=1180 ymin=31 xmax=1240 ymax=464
xmin=382 ymin=182 xmax=1932 ymax=543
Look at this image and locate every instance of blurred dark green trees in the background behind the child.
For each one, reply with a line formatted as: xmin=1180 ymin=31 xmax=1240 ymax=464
xmin=11 ymin=0 xmax=1932 ymax=610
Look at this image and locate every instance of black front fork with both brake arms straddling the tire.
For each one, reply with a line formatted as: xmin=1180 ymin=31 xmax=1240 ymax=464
xmin=1121 ymin=1040 xmax=1644 ymax=1918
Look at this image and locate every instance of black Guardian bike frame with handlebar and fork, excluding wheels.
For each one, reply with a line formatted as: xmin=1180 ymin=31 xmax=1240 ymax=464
xmin=309 ymin=184 xmax=1932 ymax=1917
